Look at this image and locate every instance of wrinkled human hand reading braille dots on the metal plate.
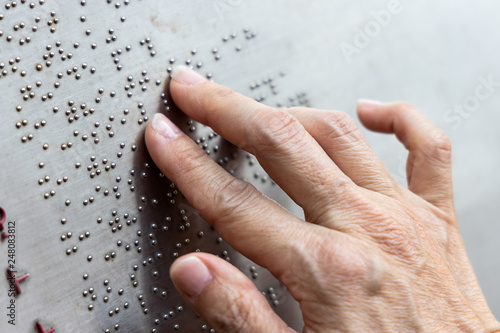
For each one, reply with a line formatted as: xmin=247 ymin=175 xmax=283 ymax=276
xmin=146 ymin=68 xmax=500 ymax=332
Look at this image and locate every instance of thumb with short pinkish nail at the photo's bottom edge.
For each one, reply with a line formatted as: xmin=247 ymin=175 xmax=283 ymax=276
xmin=170 ymin=253 xmax=294 ymax=333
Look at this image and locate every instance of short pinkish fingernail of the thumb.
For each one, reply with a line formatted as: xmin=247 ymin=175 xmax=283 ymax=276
xmin=170 ymin=256 xmax=212 ymax=297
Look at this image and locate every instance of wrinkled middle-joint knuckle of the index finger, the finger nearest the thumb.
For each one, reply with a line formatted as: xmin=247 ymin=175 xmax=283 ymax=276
xmin=209 ymin=175 xmax=257 ymax=229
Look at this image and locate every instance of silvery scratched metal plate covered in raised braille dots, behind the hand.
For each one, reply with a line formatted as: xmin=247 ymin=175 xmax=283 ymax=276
xmin=0 ymin=0 xmax=500 ymax=332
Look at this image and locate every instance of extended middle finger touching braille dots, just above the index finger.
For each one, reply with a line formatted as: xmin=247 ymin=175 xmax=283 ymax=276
xmin=170 ymin=67 xmax=356 ymax=223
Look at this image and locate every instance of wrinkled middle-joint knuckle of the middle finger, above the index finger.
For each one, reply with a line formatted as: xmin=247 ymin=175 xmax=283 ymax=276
xmin=251 ymin=108 xmax=306 ymax=149
